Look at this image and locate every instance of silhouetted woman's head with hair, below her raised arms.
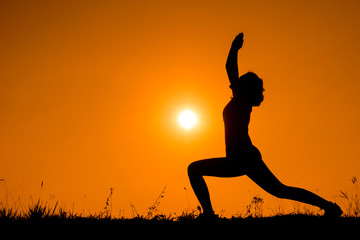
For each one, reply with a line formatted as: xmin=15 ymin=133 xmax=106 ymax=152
xmin=230 ymin=72 xmax=264 ymax=106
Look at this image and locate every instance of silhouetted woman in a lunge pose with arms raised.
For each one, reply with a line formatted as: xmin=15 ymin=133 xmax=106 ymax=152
xmin=188 ymin=33 xmax=342 ymax=217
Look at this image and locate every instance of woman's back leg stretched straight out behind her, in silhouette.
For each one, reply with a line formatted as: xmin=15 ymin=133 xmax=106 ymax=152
xmin=247 ymin=159 xmax=332 ymax=209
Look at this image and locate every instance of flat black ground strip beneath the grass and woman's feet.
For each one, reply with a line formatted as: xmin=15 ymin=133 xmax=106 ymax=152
xmin=0 ymin=215 xmax=360 ymax=239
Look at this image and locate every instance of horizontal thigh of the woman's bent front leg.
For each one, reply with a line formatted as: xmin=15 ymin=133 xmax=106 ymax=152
xmin=188 ymin=157 xmax=245 ymax=177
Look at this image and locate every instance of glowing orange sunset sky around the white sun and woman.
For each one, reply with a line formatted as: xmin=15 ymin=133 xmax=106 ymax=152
xmin=0 ymin=0 xmax=360 ymax=216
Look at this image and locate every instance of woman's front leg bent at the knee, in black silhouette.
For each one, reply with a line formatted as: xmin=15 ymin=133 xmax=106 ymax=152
xmin=188 ymin=158 xmax=244 ymax=215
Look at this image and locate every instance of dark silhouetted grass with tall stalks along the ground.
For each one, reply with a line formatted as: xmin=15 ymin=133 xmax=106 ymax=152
xmin=0 ymin=177 xmax=360 ymax=226
